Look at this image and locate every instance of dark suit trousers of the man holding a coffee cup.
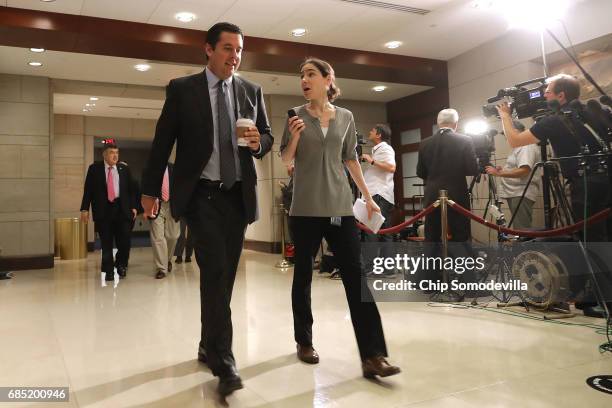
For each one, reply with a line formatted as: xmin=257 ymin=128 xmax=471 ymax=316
xmin=185 ymin=182 xmax=247 ymax=377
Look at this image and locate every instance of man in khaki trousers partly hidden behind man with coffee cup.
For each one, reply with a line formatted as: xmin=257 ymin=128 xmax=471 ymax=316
xmin=149 ymin=163 xmax=180 ymax=279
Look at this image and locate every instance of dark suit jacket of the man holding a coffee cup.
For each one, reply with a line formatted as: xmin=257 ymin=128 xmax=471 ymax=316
xmin=142 ymin=72 xmax=274 ymax=224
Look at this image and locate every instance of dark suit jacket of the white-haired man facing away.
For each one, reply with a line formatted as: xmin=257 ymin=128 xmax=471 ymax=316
xmin=417 ymin=129 xmax=478 ymax=208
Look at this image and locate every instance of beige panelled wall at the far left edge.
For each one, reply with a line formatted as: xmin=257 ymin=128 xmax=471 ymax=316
xmin=0 ymin=74 xmax=53 ymax=256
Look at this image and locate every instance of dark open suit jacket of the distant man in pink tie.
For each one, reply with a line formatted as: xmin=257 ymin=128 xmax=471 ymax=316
xmin=81 ymin=161 xmax=137 ymax=222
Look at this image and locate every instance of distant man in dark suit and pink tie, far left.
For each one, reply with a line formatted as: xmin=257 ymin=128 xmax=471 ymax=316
xmin=81 ymin=139 xmax=137 ymax=281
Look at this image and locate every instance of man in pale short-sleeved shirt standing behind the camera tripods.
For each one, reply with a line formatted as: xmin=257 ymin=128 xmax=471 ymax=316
xmin=485 ymin=120 xmax=541 ymax=229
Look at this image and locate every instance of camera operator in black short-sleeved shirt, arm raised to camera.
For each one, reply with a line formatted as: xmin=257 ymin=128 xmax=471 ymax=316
xmin=497 ymin=74 xmax=610 ymax=242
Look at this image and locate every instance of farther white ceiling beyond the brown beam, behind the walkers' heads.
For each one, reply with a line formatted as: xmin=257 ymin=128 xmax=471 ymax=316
xmin=0 ymin=45 xmax=431 ymax=119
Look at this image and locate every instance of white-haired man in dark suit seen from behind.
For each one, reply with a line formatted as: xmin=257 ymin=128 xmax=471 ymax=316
xmin=417 ymin=109 xmax=478 ymax=278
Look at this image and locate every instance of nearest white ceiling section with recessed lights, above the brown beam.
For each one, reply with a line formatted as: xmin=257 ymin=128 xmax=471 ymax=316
xmin=0 ymin=0 xmax=524 ymax=60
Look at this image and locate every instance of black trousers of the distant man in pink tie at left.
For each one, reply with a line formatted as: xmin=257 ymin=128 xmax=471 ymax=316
xmin=95 ymin=199 xmax=133 ymax=274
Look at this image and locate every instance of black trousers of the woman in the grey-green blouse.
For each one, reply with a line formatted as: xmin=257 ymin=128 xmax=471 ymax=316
xmin=291 ymin=217 xmax=387 ymax=360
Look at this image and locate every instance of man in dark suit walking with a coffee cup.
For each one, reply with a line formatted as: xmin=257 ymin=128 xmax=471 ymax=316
xmin=142 ymin=23 xmax=273 ymax=395
